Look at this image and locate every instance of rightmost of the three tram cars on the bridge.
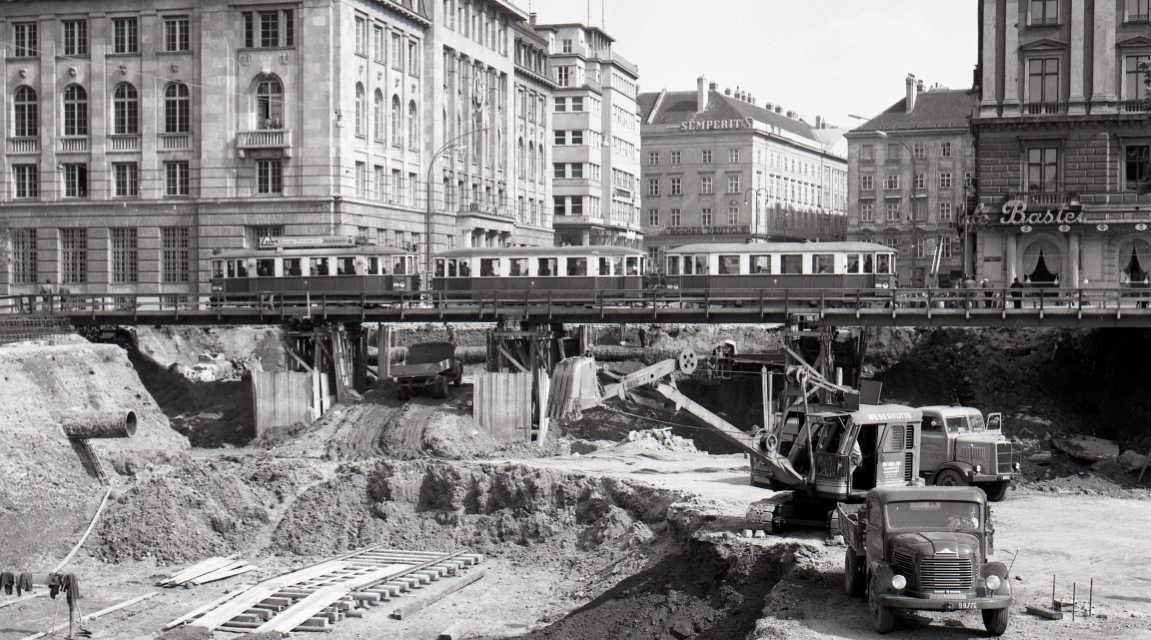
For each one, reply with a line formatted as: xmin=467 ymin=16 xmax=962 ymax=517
xmin=664 ymin=242 xmax=897 ymax=291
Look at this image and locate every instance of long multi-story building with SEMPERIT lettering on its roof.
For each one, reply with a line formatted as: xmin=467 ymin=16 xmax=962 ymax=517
xmin=639 ymin=77 xmax=847 ymax=265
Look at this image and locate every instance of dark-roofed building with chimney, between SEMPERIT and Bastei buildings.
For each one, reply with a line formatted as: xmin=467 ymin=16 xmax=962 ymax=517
xmin=846 ymin=76 xmax=978 ymax=287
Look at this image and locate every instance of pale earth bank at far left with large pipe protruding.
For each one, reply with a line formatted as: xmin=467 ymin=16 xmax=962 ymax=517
xmin=0 ymin=342 xmax=189 ymax=567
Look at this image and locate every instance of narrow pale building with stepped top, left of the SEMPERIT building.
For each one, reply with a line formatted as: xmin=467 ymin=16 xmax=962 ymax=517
xmin=536 ymin=24 xmax=643 ymax=247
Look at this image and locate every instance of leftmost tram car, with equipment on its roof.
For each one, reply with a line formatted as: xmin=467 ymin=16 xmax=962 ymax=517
xmin=212 ymin=236 xmax=419 ymax=295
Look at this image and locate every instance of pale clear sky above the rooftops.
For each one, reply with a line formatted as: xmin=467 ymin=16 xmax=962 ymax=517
xmin=513 ymin=0 xmax=978 ymax=128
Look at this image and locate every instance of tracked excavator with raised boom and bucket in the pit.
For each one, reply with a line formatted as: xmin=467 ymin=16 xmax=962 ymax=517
xmin=548 ymin=331 xmax=922 ymax=532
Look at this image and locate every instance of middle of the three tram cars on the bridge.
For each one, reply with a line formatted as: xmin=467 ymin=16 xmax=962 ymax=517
xmin=432 ymin=246 xmax=648 ymax=292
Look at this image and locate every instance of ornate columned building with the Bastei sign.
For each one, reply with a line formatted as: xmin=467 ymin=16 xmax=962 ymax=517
xmin=970 ymin=0 xmax=1151 ymax=288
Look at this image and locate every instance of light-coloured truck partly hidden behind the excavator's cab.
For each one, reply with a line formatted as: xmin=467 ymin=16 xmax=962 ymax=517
xmin=920 ymin=405 xmax=1022 ymax=502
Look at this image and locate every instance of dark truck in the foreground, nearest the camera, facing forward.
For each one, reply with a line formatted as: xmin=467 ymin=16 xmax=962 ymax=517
xmin=837 ymin=487 xmax=1012 ymax=635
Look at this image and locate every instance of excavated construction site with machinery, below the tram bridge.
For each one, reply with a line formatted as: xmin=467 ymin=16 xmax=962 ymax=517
xmin=0 ymin=320 xmax=1151 ymax=640
